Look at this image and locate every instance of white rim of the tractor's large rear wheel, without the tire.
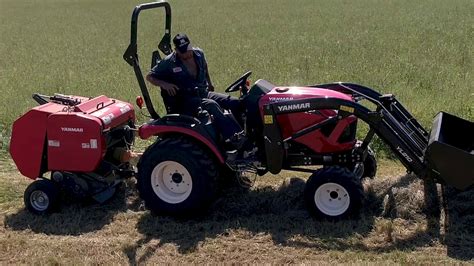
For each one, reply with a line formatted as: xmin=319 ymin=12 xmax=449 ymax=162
xmin=151 ymin=161 xmax=193 ymax=204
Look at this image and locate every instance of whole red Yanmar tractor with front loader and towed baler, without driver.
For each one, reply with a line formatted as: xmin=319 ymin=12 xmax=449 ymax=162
xmin=11 ymin=2 xmax=474 ymax=219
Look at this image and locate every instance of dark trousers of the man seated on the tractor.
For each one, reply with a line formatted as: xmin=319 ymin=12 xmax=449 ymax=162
xmin=162 ymin=92 xmax=242 ymax=139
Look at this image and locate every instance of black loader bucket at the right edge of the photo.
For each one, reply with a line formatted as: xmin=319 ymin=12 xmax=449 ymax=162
xmin=425 ymin=112 xmax=474 ymax=190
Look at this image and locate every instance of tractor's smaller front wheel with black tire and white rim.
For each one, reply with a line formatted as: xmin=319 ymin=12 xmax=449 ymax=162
xmin=304 ymin=166 xmax=364 ymax=220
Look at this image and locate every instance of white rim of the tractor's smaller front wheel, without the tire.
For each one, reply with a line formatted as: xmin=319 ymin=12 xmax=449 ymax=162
xmin=314 ymin=183 xmax=351 ymax=216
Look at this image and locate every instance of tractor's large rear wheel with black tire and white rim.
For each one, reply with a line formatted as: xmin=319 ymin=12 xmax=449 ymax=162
xmin=137 ymin=138 xmax=218 ymax=216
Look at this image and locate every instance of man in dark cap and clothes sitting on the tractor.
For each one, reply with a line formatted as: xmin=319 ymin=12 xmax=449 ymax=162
xmin=146 ymin=33 xmax=245 ymax=149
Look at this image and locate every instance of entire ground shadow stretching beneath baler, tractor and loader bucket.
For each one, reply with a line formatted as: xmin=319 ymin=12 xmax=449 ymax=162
xmin=4 ymin=172 xmax=474 ymax=264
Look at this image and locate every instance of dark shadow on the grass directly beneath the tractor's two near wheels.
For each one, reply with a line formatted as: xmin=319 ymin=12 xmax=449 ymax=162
xmin=123 ymin=178 xmax=374 ymax=265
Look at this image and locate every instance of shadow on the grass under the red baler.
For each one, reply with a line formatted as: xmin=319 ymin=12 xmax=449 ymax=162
xmin=4 ymin=182 xmax=141 ymax=235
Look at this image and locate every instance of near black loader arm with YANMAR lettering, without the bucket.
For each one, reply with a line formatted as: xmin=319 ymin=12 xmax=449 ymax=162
xmin=264 ymin=95 xmax=426 ymax=176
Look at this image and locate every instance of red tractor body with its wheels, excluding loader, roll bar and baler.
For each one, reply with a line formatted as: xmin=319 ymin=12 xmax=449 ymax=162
xmin=131 ymin=72 xmax=377 ymax=217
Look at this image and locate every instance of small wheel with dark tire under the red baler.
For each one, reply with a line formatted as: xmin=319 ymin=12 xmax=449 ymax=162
xmin=23 ymin=179 xmax=60 ymax=215
